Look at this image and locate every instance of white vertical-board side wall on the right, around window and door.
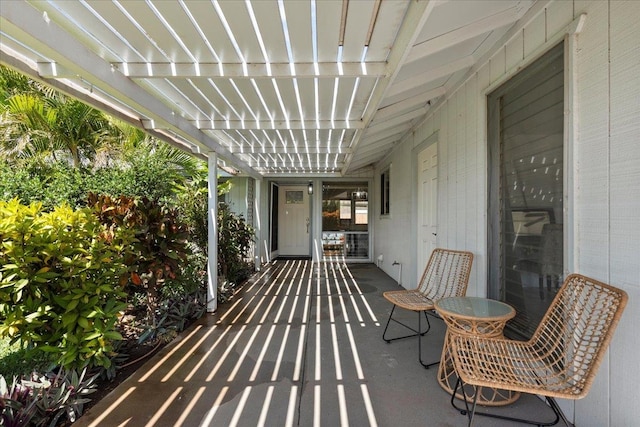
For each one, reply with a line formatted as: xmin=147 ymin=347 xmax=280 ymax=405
xmin=374 ymin=0 xmax=640 ymax=427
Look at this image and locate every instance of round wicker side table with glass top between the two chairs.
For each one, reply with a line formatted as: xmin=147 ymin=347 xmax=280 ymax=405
xmin=435 ymin=297 xmax=520 ymax=409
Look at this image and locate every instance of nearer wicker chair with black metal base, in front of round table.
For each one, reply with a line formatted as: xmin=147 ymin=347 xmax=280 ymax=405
xmin=452 ymin=274 xmax=628 ymax=426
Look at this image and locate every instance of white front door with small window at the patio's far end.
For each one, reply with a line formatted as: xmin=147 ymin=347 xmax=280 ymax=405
xmin=278 ymin=186 xmax=311 ymax=256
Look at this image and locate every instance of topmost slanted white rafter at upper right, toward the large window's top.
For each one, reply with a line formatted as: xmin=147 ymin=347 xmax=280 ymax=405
xmin=406 ymin=4 xmax=526 ymax=63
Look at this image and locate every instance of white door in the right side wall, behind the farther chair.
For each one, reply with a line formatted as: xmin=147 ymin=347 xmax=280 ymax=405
xmin=417 ymin=143 xmax=438 ymax=280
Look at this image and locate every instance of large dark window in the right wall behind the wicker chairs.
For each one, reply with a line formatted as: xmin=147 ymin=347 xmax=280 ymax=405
xmin=487 ymin=43 xmax=564 ymax=338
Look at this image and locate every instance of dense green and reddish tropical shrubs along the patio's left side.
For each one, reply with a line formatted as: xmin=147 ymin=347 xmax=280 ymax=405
xmin=0 ymin=62 xmax=254 ymax=412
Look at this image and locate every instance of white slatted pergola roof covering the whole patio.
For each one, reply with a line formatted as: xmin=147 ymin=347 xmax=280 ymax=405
xmin=0 ymin=0 xmax=534 ymax=177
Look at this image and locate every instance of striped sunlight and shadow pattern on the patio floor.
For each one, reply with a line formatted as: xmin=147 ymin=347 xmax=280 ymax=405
xmin=74 ymin=260 xmax=388 ymax=426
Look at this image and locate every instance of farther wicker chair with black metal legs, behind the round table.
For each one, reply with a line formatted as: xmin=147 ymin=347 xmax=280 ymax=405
xmin=382 ymin=249 xmax=473 ymax=368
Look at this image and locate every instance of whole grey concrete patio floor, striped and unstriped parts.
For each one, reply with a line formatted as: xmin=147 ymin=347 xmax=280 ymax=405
xmin=74 ymin=260 xmax=563 ymax=427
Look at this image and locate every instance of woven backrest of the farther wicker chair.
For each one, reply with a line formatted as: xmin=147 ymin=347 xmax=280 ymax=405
xmin=417 ymin=248 xmax=473 ymax=302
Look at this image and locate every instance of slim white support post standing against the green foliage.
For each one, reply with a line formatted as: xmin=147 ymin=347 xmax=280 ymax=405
xmin=207 ymin=151 xmax=218 ymax=313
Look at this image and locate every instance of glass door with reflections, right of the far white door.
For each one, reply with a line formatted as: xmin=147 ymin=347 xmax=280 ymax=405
xmin=322 ymin=182 xmax=369 ymax=259
